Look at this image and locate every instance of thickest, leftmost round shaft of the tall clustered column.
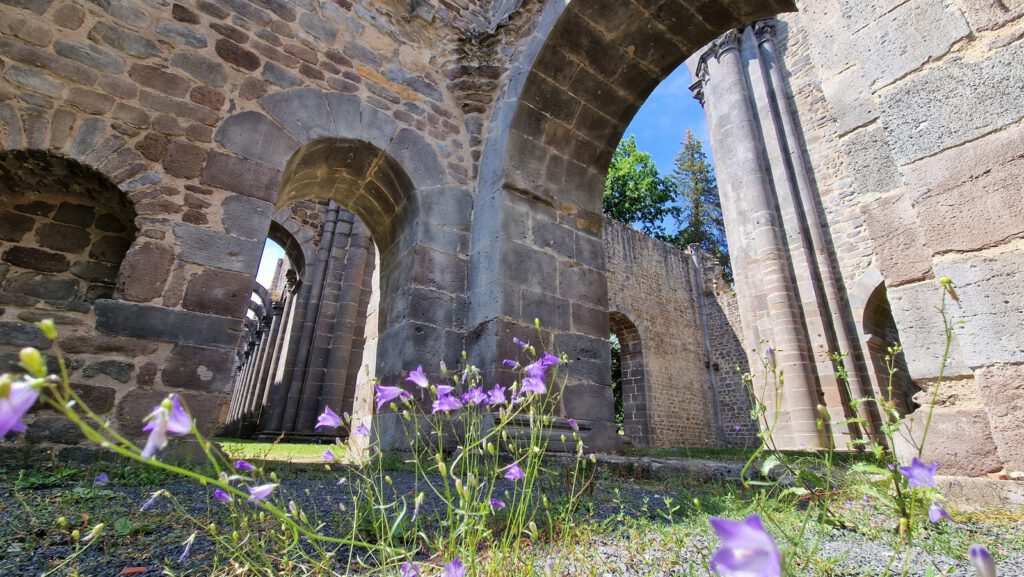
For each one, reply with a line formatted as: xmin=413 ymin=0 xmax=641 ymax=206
xmin=697 ymin=31 xmax=822 ymax=448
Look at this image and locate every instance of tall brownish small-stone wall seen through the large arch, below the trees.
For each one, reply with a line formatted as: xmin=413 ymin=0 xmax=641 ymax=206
xmin=604 ymin=220 xmax=753 ymax=447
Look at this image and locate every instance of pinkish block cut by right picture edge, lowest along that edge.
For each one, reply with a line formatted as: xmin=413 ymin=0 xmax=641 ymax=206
xmin=975 ymin=365 xmax=1024 ymax=471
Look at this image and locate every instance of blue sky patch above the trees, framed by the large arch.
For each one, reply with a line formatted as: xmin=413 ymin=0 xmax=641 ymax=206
xmin=623 ymin=65 xmax=711 ymax=175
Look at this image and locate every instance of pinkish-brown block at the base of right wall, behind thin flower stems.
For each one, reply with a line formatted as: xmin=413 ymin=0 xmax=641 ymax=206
xmin=896 ymin=407 xmax=1002 ymax=477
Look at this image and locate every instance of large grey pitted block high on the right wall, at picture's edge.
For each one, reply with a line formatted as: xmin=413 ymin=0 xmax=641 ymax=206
xmin=880 ymin=42 xmax=1024 ymax=164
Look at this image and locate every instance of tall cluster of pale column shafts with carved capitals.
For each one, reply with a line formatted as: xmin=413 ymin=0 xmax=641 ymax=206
xmin=691 ymin=22 xmax=871 ymax=448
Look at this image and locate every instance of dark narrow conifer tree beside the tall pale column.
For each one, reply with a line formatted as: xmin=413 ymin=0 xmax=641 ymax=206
xmin=671 ymin=130 xmax=731 ymax=276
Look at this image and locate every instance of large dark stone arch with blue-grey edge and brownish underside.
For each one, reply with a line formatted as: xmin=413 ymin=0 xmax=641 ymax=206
xmin=469 ymin=0 xmax=795 ymax=448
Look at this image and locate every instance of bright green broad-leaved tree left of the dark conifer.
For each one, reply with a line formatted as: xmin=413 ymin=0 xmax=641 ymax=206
xmin=604 ymin=135 xmax=679 ymax=240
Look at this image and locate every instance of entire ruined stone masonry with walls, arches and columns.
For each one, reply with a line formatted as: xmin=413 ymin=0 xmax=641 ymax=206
xmin=0 ymin=0 xmax=1024 ymax=476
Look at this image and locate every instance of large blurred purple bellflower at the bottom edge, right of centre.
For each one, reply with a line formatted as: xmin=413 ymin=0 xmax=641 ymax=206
xmin=709 ymin=514 xmax=782 ymax=577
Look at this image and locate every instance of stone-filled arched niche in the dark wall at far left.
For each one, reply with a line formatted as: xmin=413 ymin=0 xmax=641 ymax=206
xmin=0 ymin=151 xmax=136 ymax=372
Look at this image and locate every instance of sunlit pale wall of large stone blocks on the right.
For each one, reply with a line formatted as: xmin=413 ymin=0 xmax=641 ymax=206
xmin=781 ymin=0 xmax=1024 ymax=475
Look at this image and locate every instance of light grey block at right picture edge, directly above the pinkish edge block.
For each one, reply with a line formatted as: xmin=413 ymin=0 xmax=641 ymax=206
xmin=937 ymin=246 xmax=1024 ymax=367
